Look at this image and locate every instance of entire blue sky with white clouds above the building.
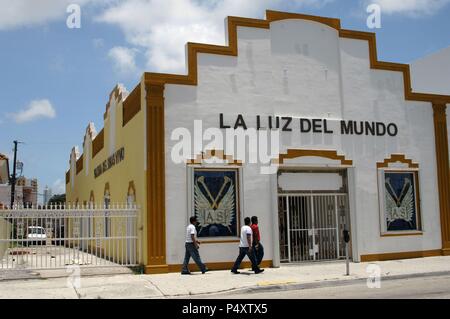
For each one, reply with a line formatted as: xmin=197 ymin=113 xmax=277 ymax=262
xmin=0 ymin=0 xmax=450 ymax=199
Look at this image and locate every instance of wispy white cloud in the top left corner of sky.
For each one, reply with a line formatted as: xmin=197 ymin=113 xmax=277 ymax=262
xmin=0 ymin=0 xmax=94 ymax=30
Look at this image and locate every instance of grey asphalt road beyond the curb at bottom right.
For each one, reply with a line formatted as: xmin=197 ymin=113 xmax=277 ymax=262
xmin=208 ymin=276 xmax=450 ymax=299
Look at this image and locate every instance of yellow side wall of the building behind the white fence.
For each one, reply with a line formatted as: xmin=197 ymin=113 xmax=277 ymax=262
xmin=66 ymin=85 xmax=146 ymax=264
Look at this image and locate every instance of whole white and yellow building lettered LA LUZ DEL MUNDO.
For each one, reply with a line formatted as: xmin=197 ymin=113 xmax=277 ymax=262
xmin=66 ymin=11 xmax=450 ymax=273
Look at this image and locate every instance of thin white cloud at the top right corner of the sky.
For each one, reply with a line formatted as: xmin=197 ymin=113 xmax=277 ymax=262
xmin=366 ymin=0 xmax=450 ymax=17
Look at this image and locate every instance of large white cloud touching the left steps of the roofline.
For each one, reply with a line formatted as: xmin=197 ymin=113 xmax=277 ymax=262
xmin=97 ymin=0 xmax=333 ymax=73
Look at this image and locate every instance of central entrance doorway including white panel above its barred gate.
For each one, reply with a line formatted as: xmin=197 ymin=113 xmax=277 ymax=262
xmin=278 ymin=170 xmax=350 ymax=262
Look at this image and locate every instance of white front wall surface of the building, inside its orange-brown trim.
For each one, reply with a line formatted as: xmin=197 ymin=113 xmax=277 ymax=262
xmin=164 ymin=19 xmax=441 ymax=265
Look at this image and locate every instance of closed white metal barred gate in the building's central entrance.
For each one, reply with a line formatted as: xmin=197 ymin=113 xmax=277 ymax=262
xmin=278 ymin=193 xmax=349 ymax=262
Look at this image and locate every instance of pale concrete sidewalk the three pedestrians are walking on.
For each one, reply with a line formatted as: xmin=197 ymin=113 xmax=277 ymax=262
xmin=0 ymin=256 xmax=450 ymax=299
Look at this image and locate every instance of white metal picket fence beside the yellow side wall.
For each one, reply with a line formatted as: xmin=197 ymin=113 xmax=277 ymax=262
xmin=0 ymin=205 xmax=141 ymax=270
